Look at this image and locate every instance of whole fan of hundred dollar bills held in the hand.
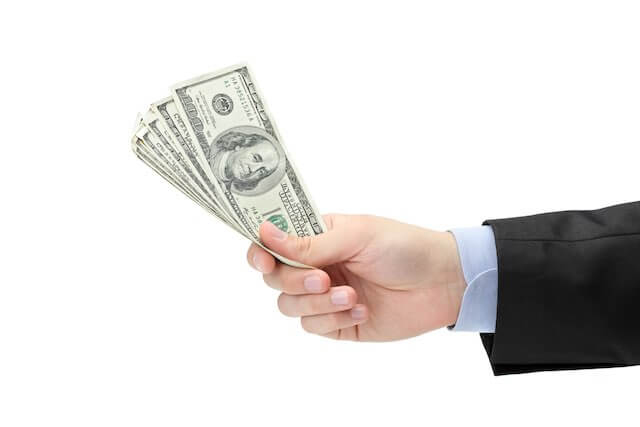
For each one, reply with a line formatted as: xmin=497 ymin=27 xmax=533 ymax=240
xmin=131 ymin=64 xmax=326 ymax=267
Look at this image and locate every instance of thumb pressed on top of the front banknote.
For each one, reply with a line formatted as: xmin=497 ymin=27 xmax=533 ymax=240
xmin=260 ymin=217 xmax=357 ymax=267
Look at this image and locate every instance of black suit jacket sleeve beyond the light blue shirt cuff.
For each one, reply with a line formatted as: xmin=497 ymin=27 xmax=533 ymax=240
xmin=481 ymin=202 xmax=640 ymax=375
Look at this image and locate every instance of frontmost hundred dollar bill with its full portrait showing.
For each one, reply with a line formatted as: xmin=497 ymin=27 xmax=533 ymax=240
xmin=172 ymin=65 xmax=326 ymax=244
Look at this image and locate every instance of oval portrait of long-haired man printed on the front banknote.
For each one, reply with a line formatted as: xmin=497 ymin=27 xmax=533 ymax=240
xmin=209 ymin=126 xmax=286 ymax=196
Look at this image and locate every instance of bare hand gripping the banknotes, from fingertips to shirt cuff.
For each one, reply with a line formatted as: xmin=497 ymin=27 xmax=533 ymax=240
xmin=247 ymin=215 xmax=466 ymax=341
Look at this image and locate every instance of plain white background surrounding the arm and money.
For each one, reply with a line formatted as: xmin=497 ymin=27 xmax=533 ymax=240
xmin=0 ymin=1 xmax=640 ymax=426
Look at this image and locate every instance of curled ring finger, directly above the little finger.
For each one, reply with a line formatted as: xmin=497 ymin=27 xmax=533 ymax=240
xmin=278 ymin=286 xmax=358 ymax=317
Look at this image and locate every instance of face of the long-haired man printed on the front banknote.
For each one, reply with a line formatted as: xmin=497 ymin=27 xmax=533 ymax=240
xmin=227 ymin=141 xmax=278 ymax=182
